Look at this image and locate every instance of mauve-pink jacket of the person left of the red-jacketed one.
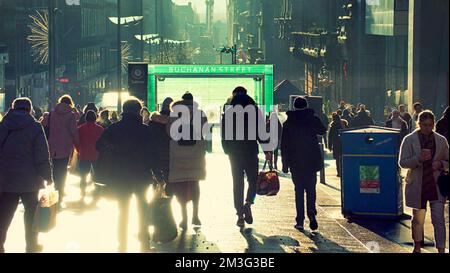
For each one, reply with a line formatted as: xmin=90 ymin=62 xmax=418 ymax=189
xmin=42 ymin=103 xmax=79 ymax=159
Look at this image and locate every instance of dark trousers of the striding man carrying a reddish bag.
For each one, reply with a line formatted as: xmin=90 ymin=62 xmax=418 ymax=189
xmin=229 ymin=155 xmax=259 ymax=216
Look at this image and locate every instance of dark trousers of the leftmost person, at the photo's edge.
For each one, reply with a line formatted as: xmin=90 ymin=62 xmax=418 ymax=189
xmin=0 ymin=192 xmax=38 ymax=253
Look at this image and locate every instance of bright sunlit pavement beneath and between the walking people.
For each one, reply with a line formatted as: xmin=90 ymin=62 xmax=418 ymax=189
xmin=5 ymin=154 xmax=448 ymax=253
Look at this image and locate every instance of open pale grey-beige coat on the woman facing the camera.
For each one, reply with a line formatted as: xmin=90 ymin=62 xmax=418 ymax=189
xmin=399 ymin=130 xmax=449 ymax=209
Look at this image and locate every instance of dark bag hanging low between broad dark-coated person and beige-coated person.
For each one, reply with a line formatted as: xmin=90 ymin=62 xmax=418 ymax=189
xmin=147 ymin=183 xmax=178 ymax=243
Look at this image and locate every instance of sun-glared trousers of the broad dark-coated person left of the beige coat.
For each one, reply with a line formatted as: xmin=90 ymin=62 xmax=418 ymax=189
xmin=118 ymin=186 xmax=150 ymax=252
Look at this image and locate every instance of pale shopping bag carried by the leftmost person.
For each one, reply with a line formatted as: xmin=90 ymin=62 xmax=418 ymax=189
xmin=33 ymin=184 xmax=59 ymax=232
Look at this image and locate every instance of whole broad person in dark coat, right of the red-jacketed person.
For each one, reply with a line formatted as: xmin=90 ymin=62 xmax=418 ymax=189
xmin=96 ymin=97 xmax=156 ymax=252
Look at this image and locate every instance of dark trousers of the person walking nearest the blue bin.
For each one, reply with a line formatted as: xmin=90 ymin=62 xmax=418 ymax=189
xmin=291 ymin=170 xmax=317 ymax=224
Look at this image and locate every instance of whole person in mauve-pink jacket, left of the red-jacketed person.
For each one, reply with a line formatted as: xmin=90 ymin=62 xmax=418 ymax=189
xmin=42 ymin=95 xmax=79 ymax=208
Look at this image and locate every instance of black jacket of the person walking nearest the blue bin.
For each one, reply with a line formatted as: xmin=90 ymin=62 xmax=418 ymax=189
xmin=281 ymin=109 xmax=327 ymax=172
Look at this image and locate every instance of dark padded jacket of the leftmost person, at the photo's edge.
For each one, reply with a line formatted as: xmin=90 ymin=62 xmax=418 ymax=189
xmin=0 ymin=110 xmax=52 ymax=193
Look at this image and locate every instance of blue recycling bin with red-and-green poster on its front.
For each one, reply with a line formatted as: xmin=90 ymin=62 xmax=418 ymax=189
xmin=341 ymin=126 xmax=403 ymax=218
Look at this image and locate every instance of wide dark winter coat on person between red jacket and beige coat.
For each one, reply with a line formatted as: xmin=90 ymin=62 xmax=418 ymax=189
xmin=95 ymin=113 xmax=157 ymax=192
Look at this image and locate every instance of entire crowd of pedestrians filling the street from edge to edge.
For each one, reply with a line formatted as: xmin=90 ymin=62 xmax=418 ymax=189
xmin=0 ymin=92 xmax=448 ymax=252
